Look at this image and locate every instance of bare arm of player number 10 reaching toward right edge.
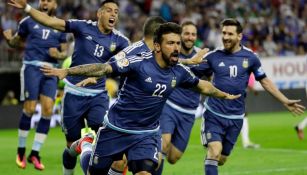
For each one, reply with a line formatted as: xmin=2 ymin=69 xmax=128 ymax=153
xmin=260 ymin=77 xmax=305 ymax=116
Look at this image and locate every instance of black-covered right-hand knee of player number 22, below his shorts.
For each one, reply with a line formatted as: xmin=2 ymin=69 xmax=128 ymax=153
xmin=128 ymin=160 xmax=157 ymax=175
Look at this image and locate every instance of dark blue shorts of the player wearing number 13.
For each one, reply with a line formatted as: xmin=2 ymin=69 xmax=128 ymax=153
xmin=62 ymin=92 xmax=109 ymax=142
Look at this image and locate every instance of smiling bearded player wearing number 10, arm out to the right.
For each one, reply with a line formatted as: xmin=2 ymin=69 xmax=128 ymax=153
xmin=202 ymin=19 xmax=305 ymax=175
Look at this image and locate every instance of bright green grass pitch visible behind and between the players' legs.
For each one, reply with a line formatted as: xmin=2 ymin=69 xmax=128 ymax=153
xmin=0 ymin=112 xmax=307 ymax=175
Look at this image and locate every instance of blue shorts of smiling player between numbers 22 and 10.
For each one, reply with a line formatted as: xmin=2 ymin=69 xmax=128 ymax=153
xmin=160 ymin=104 xmax=195 ymax=152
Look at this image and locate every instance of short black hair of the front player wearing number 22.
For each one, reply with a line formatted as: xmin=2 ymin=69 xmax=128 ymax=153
xmin=154 ymin=22 xmax=182 ymax=44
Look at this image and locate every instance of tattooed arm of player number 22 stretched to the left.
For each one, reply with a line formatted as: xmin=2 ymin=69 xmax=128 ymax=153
xmin=41 ymin=63 xmax=112 ymax=79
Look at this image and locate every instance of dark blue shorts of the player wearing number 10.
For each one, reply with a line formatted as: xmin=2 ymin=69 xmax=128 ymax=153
xmin=201 ymin=110 xmax=243 ymax=156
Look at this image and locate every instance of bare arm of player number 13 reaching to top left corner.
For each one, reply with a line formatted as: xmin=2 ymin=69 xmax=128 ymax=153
xmin=8 ymin=0 xmax=65 ymax=31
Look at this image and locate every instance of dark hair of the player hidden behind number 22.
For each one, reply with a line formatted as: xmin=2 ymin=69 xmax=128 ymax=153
xmin=143 ymin=16 xmax=166 ymax=37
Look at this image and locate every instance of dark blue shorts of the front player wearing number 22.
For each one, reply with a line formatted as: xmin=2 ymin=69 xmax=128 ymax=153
xmin=90 ymin=127 xmax=161 ymax=168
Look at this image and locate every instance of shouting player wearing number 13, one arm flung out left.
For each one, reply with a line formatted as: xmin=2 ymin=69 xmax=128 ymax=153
xmin=10 ymin=0 xmax=129 ymax=175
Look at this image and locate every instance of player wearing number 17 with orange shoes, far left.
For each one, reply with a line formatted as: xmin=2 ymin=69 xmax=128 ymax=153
xmin=3 ymin=0 xmax=67 ymax=170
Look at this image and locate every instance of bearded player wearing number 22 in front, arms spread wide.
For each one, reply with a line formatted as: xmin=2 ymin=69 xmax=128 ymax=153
xmin=42 ymin=23 xmax=240 ymax=175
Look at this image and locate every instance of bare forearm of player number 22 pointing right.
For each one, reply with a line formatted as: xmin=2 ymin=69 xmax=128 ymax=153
xmin=197 ymin=80 xmax=241 ymax=100
